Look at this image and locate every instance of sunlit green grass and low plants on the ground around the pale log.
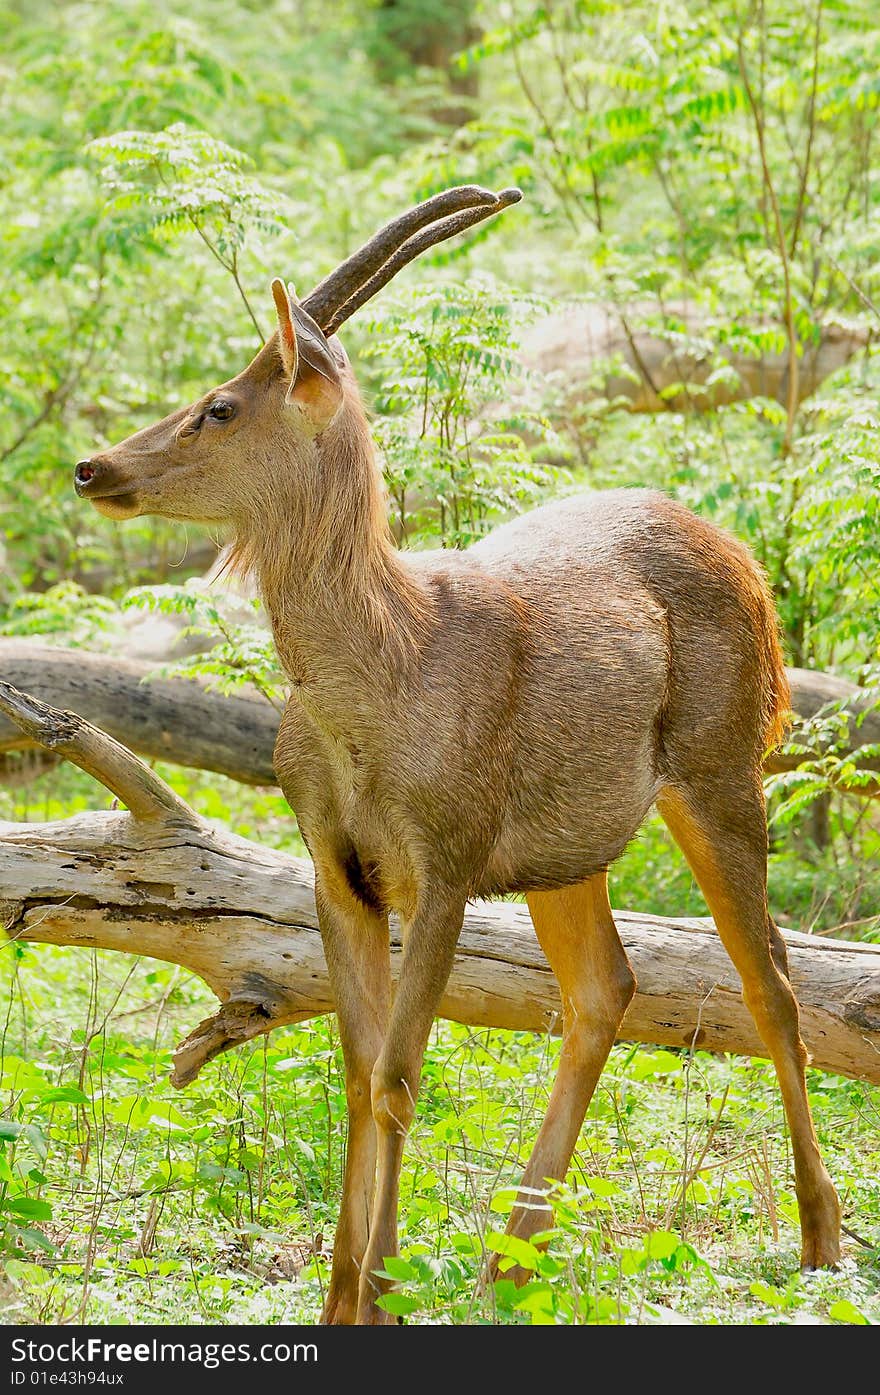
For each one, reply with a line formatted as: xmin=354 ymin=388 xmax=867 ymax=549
xmin=0 ymin=770 xmax=880 ymax=1324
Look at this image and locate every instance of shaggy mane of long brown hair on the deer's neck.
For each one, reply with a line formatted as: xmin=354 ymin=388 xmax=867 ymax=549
xmin=230 ymin=385 xmax=431 ymax=653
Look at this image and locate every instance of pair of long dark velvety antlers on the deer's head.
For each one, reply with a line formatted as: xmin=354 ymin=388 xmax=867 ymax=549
xmin=303 ymin=184 xmax=523 ymax=335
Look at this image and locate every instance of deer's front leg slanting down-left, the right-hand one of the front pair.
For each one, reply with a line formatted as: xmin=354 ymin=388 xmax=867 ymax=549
xmin=357 ymin=887 xmax=466 ymax=1325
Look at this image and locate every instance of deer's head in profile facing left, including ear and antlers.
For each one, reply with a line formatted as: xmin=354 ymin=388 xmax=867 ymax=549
xmin=74 ymin=186 xmax=522 ymax=523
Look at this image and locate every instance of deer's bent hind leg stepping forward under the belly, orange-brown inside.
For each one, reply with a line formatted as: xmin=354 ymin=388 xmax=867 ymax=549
xmin=495 ymin=872 xmax=636 ymax=1281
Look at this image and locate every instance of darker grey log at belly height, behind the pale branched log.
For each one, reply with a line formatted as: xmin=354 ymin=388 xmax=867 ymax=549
xmin=0 ymin=639 xmax=880 ymax=795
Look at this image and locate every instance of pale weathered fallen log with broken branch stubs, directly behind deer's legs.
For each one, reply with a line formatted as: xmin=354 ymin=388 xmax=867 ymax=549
xmin=0 ymin=684 xmax=880 ymax=1085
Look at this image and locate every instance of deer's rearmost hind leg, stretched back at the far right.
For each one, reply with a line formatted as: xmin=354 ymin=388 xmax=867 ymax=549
xmin=657 ymin=777 xmax=840 ymax=1269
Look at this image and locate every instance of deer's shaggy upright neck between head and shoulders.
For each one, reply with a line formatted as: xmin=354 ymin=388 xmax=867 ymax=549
xmin=236 ymin=405 xmax=431 ymax=710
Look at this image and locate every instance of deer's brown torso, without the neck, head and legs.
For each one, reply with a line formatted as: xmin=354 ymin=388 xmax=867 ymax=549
xmin=276 ymin=491 xmax=708 ymax=912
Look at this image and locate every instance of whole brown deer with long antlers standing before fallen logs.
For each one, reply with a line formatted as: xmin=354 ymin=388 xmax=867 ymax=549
xmin=75 ymin=187 xmax=840 ymax=1324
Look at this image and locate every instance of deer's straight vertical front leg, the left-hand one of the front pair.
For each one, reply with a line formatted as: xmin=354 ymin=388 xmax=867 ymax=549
xmin=315 ymin=866 xmax=390 ymax=1324
